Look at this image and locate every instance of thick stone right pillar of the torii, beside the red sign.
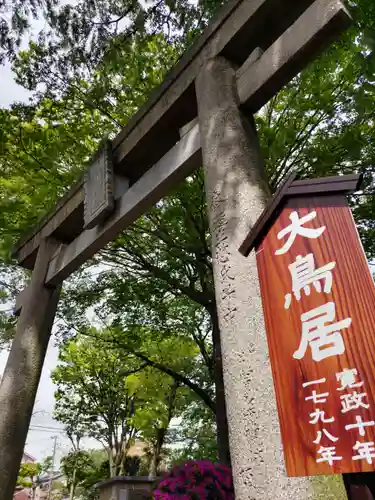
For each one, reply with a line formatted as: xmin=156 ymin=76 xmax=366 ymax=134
xmin=196 ymin=57 xmax=347 ymax=500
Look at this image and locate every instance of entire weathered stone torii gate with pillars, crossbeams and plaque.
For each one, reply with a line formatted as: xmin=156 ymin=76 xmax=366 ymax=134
xmin=0 ymin=0 xmax=350 ymax=500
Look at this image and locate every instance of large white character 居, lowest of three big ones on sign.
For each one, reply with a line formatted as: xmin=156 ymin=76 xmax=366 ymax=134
xmin=293 ymin=302 xmax=352 ymax=361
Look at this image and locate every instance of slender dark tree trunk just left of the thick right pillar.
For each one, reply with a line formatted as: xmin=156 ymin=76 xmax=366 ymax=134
xmin=210 ymin=302 xmax=231 ymax=467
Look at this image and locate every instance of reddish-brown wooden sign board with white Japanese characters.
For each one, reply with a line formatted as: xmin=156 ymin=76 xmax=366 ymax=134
xmin=256 ymin=184 xmax=375 ymax=476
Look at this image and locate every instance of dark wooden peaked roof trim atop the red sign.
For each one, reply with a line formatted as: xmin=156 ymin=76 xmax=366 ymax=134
xmin=238 ymin=172 xmax=363 ymax=257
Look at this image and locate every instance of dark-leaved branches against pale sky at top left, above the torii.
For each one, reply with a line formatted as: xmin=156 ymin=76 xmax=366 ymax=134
xmin=0 ymin=0 xmax=221 ymax=86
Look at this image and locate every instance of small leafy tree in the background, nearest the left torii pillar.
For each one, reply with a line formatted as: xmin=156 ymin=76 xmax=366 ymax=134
xmin=52 ymin=339 xmax=141 ymax=477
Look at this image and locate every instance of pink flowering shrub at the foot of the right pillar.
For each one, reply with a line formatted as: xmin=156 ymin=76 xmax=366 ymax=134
xmin=154 ymin=460 xmax=234 ymax=500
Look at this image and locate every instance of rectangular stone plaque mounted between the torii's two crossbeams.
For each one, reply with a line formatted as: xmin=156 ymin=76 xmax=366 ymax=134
xmin=84 ymin=141 xmax=114 ymax=229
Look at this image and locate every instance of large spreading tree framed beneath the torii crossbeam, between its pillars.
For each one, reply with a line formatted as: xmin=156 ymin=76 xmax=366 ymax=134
xmin=55 ymin=171 xmax=229 ymax=463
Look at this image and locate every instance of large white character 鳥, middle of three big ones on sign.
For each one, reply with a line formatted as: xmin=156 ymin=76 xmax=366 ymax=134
xmin=284 ymin=253 xmax=336 ymax=309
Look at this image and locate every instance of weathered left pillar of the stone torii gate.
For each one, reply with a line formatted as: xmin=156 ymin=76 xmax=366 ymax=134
xmin=0 ymin=241 xmax=60 ymax=500
